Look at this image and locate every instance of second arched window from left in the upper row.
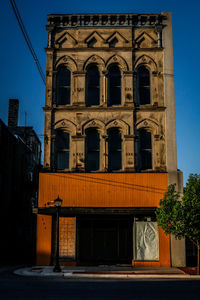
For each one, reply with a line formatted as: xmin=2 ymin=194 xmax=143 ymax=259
xmin=86 ymin=64 xmax=100 ymax=106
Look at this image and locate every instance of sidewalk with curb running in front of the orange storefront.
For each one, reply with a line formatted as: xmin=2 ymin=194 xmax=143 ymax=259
xmin=14 ymin=266 xmax=200 ymax=279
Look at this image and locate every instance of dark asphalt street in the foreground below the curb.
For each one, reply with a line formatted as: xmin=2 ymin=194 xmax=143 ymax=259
xmin=0 ymin=268 xmax=200 ymax=300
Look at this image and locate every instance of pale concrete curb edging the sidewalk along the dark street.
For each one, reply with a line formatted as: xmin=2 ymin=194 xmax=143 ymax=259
xmin=14 ymin=267 xmax=200 ymax=280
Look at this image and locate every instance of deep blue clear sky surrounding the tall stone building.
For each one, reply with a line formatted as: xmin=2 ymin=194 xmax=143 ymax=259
xmin=0 ymin=0 xmax=200 ymax=182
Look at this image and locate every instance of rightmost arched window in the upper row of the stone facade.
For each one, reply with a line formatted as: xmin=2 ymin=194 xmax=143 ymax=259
xmin=137 ymin=65 xmax=151 ymax=105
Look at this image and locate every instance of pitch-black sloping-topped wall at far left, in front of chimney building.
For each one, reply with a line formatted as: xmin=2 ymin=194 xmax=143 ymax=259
xmin=0 ymin=122 xmax=38 ymax=264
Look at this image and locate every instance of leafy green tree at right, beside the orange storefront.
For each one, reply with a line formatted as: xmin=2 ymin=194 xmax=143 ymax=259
xmin=156 ymin=174 xmax=200 ymax=274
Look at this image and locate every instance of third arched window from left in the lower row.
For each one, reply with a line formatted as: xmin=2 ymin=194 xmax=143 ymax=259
xmin=108 ymin=128 xmax=122 ymax=171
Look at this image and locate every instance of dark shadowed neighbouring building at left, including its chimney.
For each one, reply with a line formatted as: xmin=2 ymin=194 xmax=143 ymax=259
xmin=0 ymin=99 xmax=41 ymax=264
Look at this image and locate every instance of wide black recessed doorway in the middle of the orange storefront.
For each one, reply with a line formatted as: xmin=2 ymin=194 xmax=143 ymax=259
xmin=77 ymin=218 xmax=133 ymax=264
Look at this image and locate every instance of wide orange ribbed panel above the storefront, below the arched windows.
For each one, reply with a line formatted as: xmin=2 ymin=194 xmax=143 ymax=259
xmin=38 ymin=173 xmax=168 ymax=207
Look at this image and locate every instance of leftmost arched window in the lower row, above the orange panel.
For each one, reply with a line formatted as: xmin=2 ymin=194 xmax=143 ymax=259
xmin=55 ymin=130 xmax=70 ymax=170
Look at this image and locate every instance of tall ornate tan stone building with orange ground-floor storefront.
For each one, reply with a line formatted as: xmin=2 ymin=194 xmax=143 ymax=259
xmin=37 ymin=13 xmax=185 ymax=266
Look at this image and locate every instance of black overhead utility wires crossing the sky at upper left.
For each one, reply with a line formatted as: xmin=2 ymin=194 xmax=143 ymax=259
xmin=10 ymin=0 xmax=45 ymax=84
